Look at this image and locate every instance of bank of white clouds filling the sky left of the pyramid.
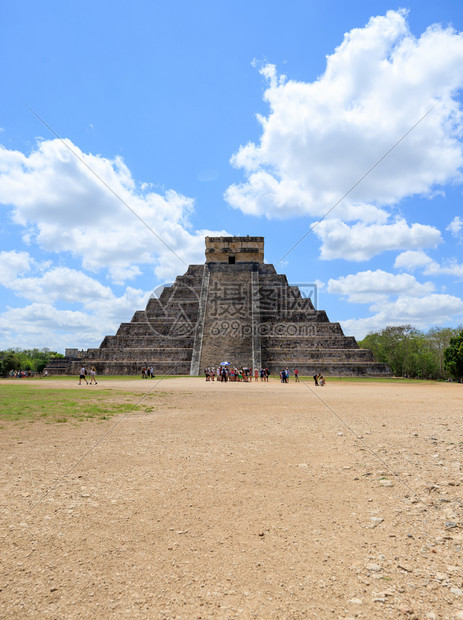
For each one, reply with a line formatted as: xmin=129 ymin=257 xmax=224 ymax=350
xmin=0 ymin=140 xmax=232 ymax=351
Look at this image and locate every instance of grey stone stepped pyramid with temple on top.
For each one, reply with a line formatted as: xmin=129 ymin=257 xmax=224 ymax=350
xmin=67 ymin=237 xmax=390 ymax=376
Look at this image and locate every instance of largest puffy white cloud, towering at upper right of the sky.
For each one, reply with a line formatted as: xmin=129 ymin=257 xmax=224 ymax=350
xmin=226 ymin=11 xmax=463 ymax=234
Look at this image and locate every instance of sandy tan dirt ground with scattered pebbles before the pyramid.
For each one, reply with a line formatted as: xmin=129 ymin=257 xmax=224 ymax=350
xmin=0 ymin=378 xmax=463 ymax=619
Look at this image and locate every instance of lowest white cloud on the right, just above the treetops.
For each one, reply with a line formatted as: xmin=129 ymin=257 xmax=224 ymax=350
xmin=341 ymin=294 xmax=463 ymax=339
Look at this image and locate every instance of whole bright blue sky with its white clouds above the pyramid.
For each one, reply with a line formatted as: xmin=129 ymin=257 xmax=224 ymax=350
xmin=0 ymin=0 xmax=463 ymax=351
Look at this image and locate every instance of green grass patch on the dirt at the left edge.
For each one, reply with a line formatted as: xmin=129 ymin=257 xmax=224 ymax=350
xmin=0 ymin=382 xmax=147 ymax=423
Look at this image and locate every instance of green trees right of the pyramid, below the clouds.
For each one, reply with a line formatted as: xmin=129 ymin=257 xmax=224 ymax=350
xmin=359 ymin=325 xmax=463 ymax=380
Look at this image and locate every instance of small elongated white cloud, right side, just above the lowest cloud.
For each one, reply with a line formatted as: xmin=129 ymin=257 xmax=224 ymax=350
xmin=327 ymin=269 xmax=434 ymax=303
